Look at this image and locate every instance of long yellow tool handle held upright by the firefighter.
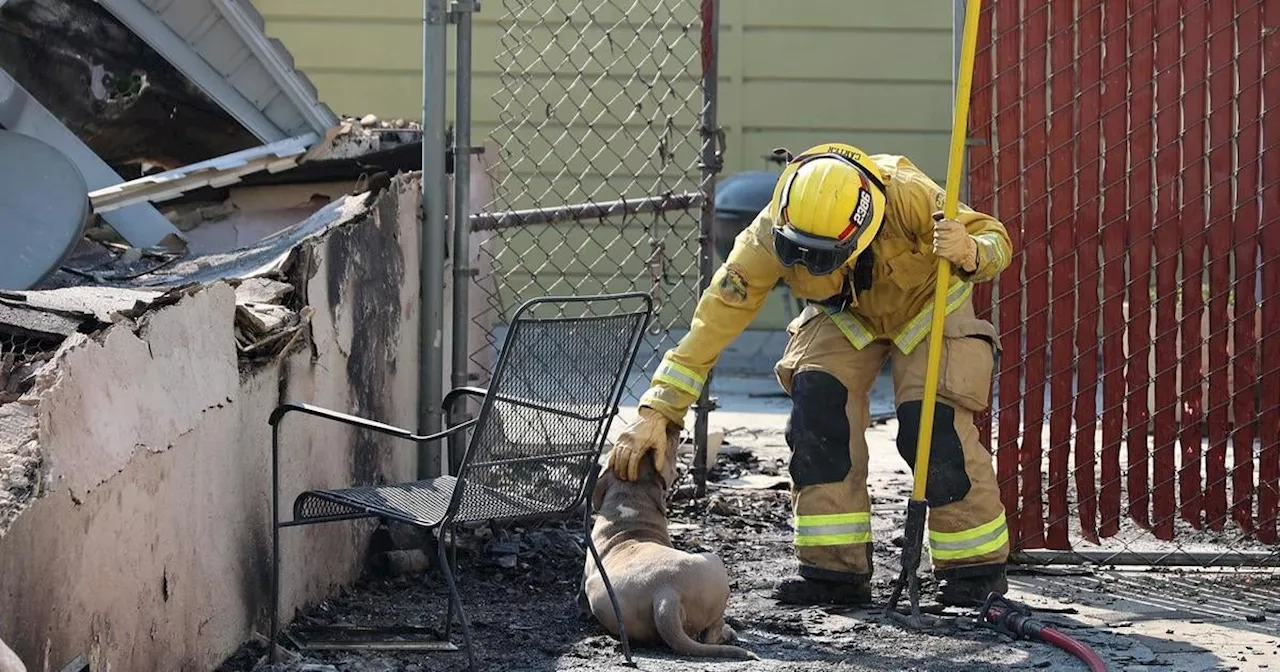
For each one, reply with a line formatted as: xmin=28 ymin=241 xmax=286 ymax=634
xmin=911 ymin=0 xmax=982 ymax=502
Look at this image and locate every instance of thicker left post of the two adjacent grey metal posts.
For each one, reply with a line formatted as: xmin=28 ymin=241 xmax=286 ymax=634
xmin=417 ymin=0 xmax=448 ymax=479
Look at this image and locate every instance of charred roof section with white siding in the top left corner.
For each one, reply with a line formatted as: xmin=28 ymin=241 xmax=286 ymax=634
xmin=0 ymin=0 xmax=338 ymax=170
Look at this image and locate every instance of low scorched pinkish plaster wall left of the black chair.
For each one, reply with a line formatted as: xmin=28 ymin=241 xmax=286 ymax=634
xmin=0 ymin=177 xmax=430 ymax=669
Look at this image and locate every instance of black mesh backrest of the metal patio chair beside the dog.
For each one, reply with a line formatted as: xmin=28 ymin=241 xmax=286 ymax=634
xmin=456 ymin=292 xmax=653 ymax=521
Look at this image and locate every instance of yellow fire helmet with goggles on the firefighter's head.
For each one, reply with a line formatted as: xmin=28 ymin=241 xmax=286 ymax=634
xmin=769 ymin=142 xmax=884 ymax=275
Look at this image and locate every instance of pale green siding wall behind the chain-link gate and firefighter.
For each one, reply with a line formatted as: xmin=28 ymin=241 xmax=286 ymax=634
xmin=255 ymin=0 xmax=952 ymax=328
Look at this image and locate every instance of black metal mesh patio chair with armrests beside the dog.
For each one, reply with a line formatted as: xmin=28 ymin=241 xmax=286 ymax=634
xmin=270 ymin=293 xmax=653 ymax=669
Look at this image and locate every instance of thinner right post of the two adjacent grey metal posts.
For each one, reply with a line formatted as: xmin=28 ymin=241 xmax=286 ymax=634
xmin=448 ymin=2 xmax=471 ymax=474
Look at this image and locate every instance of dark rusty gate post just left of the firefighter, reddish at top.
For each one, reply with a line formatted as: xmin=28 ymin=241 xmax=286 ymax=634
xmin=694 ymin=0 xmax=722 ymax=497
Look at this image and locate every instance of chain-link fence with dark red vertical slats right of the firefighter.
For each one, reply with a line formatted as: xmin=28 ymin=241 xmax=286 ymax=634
xmin=969 ymin=0 xmax=1280 ymax=566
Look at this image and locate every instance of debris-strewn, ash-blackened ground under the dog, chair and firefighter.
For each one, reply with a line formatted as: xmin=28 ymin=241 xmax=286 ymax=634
xmin=230 ymin=371 xmax=1280 ymax=672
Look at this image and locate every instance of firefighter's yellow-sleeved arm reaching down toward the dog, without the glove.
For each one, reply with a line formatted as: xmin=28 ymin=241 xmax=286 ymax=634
xmin=640 ymin=211 xmax=782 ymax=428
